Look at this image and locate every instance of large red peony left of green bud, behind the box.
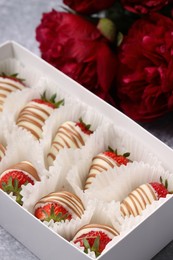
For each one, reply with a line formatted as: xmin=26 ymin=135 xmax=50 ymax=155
xmin=36 ymin=10 xmax=117 ymax=102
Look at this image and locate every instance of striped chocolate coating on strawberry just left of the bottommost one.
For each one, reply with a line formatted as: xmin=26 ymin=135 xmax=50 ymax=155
xmin=35 ymin=191 xmax=85 ymax=219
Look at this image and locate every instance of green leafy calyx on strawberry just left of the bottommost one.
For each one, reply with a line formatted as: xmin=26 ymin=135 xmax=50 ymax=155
xmin=42 ymin=205 xmax=69 ymax=222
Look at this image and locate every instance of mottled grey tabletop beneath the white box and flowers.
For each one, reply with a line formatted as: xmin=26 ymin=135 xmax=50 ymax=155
xmin=0 ymin=0 xmax=173 ymax=260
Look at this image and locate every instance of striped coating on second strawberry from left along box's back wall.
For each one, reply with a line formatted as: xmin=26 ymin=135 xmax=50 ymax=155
xmin=16 ymin=101 xmax=53 ymax=139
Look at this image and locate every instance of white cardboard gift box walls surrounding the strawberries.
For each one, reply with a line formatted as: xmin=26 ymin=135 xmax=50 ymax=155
xmin=0 ymin=42 xmax=173 ymax=260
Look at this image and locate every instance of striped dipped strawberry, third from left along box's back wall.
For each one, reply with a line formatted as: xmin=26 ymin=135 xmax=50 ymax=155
xmin=47 ymin=118 xmax=93 ymax=165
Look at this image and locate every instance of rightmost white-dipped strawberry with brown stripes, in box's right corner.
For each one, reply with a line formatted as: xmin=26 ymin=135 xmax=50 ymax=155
xmin=120 ymin=179 xmax=168 ymax=217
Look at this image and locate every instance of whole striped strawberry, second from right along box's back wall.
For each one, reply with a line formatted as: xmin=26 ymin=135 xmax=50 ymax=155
xmin=84 ymin=147 xmax=130 ymax=190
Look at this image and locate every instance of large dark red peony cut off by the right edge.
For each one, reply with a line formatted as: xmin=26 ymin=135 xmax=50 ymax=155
xmin=117 ymin=13 xmax=173 ymax=121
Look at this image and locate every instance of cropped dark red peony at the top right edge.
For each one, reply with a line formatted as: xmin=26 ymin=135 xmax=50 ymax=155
xmin=121 ymin=0 xmax=172 ymax=14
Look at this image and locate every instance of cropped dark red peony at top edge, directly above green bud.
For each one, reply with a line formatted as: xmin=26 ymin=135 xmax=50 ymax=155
xmin=63 ymin=0 xmax=116 ymax=14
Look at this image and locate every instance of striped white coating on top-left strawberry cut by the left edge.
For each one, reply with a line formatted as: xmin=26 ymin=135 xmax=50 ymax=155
xmin=0 ymin=76 xmax=25 ymax=112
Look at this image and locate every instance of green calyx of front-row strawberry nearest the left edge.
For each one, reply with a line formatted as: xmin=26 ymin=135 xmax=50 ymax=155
xmin=2 ymin=177 xmax=28 ymax=205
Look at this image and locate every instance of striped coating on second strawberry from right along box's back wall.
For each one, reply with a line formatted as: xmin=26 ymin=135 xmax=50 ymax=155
xmin=84 ymin=153 xmax=119 ymax=190
